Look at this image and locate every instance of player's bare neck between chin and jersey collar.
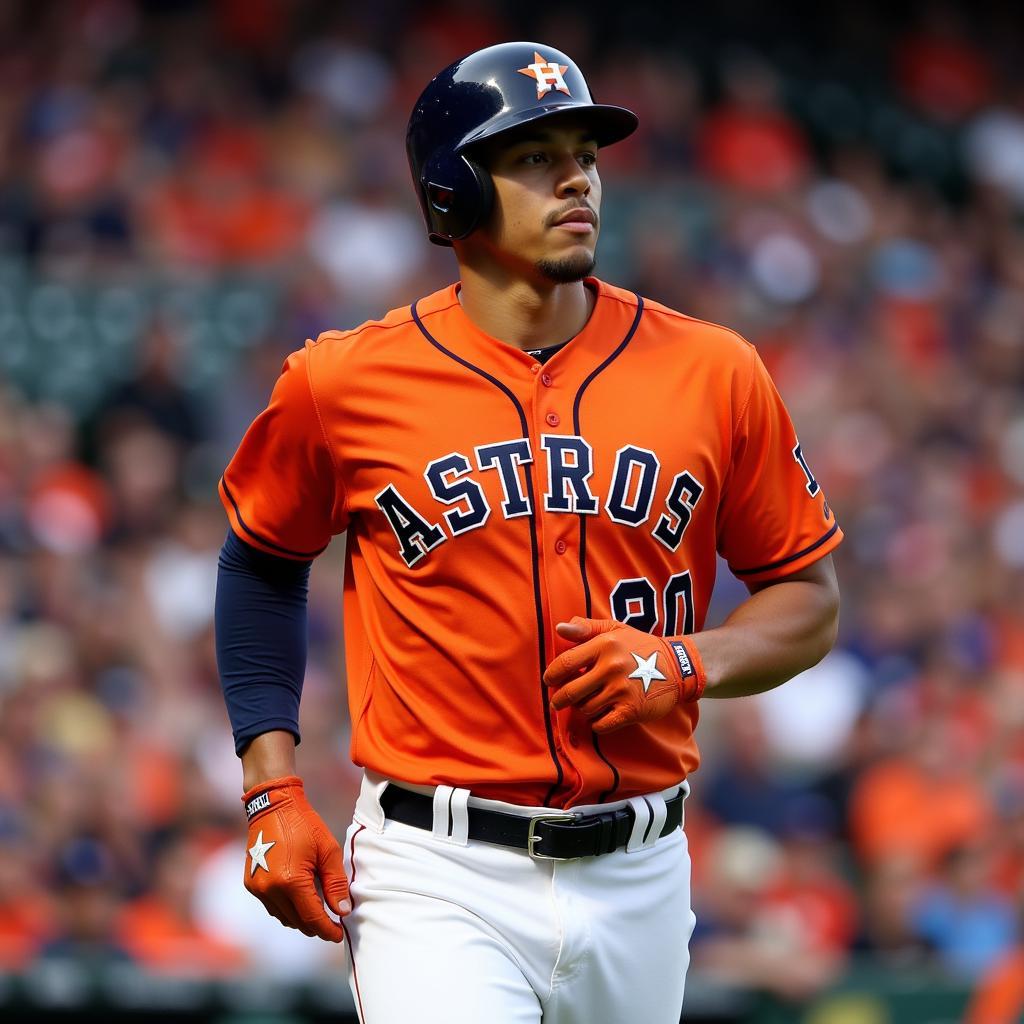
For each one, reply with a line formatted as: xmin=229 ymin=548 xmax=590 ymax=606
xmin=459 ymin=265 xmax=595 ymax=349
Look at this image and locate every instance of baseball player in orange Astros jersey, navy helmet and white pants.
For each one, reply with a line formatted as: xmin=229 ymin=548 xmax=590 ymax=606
xmin=217 ymin=43 xmax=842 ymax=1024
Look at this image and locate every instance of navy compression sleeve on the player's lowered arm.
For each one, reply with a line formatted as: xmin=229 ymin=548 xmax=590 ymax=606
xmin=214 ymin=530 xmax=312 ymax=755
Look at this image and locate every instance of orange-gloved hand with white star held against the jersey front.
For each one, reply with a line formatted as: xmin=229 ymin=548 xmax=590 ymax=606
xmin=544 ymin=615 xmax=706 ymax=732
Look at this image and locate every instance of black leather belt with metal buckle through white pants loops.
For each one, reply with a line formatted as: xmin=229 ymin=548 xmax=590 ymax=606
xmin=381 ymin=785 xmax=683 ymax=860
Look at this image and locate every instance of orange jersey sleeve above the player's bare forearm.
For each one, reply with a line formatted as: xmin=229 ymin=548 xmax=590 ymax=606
xmin=718 ymin=347 xmax=843 ymax=583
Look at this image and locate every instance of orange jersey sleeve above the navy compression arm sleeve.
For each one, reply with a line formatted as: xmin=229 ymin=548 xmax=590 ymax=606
xmin=219 ymin=342 xmax=348 ymax=560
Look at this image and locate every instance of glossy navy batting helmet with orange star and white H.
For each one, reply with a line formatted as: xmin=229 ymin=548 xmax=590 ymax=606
xmin=406 ymin=43 xmax=637 ymax=246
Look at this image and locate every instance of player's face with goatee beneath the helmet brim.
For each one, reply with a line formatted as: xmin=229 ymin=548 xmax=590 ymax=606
xmin=470 ymin=121 xmax=601 ymax=284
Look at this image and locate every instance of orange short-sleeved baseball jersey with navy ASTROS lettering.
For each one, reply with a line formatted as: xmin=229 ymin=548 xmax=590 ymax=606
xmin=220 ymin=279 xmax=842 ymax=807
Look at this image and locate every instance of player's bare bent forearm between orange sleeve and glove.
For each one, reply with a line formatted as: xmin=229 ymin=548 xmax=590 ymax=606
xmin=691 ymin=558 xmax=839 ymax=698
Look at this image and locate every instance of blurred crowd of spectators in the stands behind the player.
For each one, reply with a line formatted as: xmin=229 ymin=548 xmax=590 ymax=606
xmin=0 ymin=0 xmax=1024 ymax=1022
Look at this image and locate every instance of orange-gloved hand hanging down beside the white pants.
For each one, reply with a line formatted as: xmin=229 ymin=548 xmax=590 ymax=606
xmin=242 ymin=775 xmax=351 ymax=942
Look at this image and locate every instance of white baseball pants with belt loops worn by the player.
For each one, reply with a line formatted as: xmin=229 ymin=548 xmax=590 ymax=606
xmin=344 ymin=774 xmax=695 ymax=1024
